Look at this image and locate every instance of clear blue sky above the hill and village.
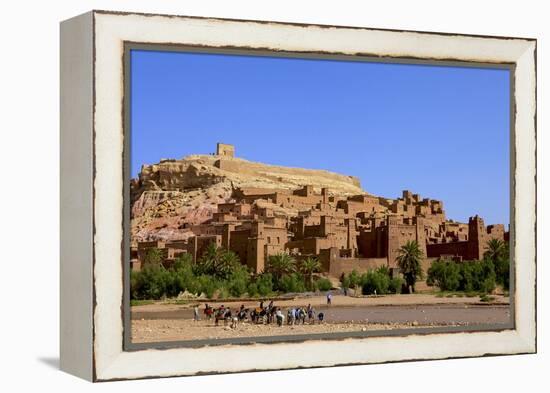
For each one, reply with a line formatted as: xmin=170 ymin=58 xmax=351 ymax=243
xmin=131 ymin=50 xmax=510 ymax=224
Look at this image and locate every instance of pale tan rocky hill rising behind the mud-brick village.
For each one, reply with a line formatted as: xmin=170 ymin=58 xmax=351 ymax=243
xmin=131 ymin=155 xmax=365 ymax=241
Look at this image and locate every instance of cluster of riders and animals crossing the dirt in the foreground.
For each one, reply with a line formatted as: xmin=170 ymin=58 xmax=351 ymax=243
xmin=193 ymin=300 xmax=330 ymax=329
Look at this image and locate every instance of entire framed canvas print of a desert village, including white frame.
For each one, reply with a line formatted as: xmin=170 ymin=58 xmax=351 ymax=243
xmin=60 ymin=11 xmax=536 ymax=381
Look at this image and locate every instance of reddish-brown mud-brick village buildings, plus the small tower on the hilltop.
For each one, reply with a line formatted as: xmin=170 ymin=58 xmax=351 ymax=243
xmin=132 ymin=143 xmax=508 ymax=276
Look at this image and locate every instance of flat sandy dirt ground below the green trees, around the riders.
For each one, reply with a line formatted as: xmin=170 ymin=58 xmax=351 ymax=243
xmin=132 ymin=294 xmax=510 ymax=343
